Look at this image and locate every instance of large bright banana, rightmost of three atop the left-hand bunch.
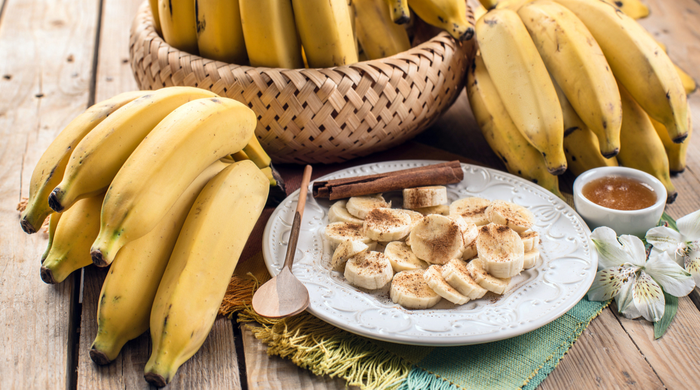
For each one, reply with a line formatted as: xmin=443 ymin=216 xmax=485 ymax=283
xmin=91 ymin=97 xmax=257 ymax=267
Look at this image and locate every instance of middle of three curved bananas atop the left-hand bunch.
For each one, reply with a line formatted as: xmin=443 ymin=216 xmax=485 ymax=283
xmin=49 ymin=87 xmax=216 ymax=211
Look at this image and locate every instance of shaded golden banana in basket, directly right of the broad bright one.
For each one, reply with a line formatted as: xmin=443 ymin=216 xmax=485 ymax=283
xmin=354 ymin=0 xmax=411 ymax=60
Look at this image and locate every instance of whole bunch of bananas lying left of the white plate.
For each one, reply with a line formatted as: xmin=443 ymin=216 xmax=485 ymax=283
xmin=21 ymin=87 xmax=274 ymax=387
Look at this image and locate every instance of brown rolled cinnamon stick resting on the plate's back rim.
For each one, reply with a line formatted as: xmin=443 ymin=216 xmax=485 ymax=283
xmin=313 ymin=160 xmax=464 ymax=200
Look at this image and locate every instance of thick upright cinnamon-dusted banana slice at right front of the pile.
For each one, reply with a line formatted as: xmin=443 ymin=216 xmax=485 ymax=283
xmin=476 ymin=223 xmax=525 ymax=278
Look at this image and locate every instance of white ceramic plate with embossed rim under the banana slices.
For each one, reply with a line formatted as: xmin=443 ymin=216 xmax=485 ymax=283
xmin=263 ymin=160 xmax=598 ymax=346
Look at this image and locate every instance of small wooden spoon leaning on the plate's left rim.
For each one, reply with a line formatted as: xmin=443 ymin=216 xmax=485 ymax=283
xmin=253 ymin=165 xmax=311 ymax=318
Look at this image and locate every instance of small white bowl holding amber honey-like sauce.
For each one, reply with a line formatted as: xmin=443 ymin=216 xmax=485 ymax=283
xmin=574 ymin=167 xmax=667 ymax=236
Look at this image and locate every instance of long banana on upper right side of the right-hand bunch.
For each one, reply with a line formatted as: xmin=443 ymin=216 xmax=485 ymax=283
xmin=556 ymin=0 xmax=688 ymax=143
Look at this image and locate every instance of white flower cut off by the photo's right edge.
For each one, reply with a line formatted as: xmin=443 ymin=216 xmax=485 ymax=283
xmin=646 ymin=210 xmax=700 ymax=286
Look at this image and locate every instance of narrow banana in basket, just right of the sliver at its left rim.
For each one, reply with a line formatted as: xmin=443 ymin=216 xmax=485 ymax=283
xmin=158 ymin=0 xmax=198 ymax=54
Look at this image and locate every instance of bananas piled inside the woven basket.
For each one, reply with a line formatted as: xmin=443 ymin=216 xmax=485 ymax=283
xmin=150 ymin=0 xmax=474 ymax=69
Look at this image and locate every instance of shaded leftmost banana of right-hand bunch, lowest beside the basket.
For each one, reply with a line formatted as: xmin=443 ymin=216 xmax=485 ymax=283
xmin=467 ymin=55 xmax=563 ymax=199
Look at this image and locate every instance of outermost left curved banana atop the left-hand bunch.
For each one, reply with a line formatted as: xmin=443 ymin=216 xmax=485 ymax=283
xmin=20 ymin=91 xmax=146 ymax=234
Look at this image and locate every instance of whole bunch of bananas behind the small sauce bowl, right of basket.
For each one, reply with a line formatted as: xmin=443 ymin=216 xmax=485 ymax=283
xmin=467 ymin=0 xmax=695 ymax=203
